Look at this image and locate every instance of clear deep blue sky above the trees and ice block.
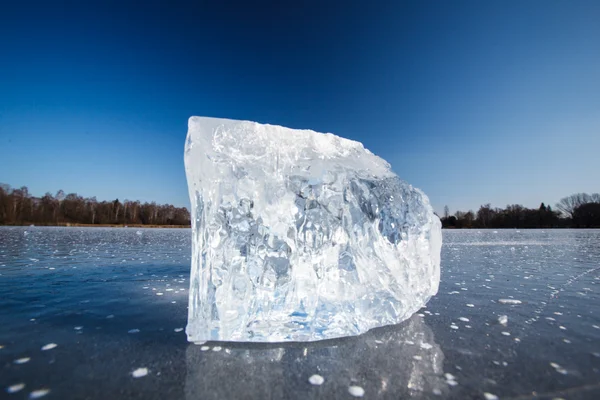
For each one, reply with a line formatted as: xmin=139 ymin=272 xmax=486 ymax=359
xmin=0 ymin=0 xmax=600 ymax=216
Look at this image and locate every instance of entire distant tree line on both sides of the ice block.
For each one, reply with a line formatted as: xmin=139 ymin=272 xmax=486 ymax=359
xmin=0 ymin=184 xmax=600 ymax=229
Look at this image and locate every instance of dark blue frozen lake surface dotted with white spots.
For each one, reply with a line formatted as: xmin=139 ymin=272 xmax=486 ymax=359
xmin=0 ymin=227 xmax=600 ymax=400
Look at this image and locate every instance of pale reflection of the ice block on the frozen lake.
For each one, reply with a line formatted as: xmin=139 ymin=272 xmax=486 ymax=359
xmin=185 ymin=315 xmax=447 ymax=400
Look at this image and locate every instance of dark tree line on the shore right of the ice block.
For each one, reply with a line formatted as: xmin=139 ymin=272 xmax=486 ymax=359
xmin=440 ymin=193 xmax=600 ymax=229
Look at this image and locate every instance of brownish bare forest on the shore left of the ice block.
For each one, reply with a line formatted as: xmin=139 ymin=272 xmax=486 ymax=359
xmin=0 ymin=184 xmax=190 ymax=226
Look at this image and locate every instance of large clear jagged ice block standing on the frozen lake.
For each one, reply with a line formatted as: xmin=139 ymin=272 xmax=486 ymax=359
xmin=185 ymin=117 xmax=442 ymax=342
